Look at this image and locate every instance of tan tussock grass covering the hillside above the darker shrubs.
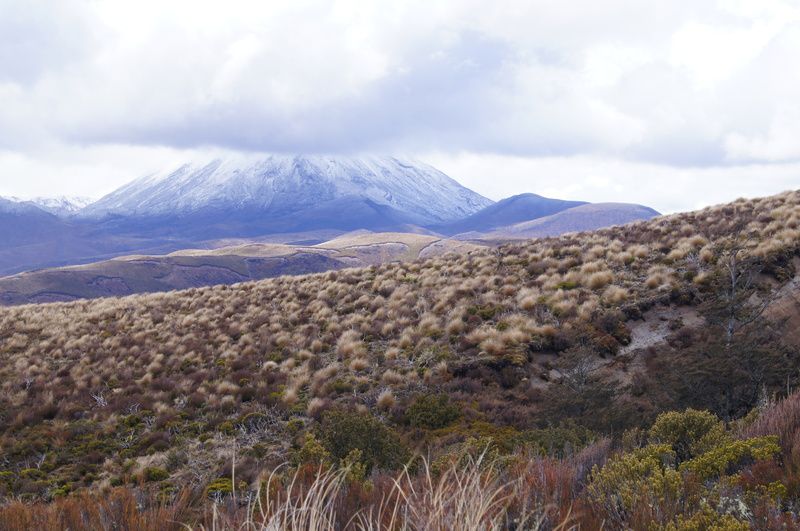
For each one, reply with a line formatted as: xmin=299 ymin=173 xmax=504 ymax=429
xmin=0 ymin=192 xmax=800 ymax=505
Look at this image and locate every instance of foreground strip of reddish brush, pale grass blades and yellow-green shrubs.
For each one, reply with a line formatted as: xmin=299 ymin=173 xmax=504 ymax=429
xmin=0 ymin=393 xmax=800 ymax=531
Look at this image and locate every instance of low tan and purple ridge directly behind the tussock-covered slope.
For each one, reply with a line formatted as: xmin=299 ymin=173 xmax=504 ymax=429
xmin=0 ymin=231 xmax=480 ymax=305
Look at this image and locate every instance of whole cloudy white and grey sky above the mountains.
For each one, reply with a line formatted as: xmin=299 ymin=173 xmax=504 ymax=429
xmin=0 ymin=0 xmax=800 ymax=212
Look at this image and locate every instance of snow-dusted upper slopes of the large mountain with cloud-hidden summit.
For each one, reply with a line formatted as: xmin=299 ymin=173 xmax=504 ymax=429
xmin=81 ymin=155 xmax=492 ymax=228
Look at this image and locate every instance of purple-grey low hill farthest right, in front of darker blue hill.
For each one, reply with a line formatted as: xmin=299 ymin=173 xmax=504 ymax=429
xmin=456 ymin=203 xmax=660 ymax=240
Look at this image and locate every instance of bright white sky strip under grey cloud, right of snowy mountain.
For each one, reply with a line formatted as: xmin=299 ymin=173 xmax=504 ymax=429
xmin=426 ymin=153 xmax=800 ymax=213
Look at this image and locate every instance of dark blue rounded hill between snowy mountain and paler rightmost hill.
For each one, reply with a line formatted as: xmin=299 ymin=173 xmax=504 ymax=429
xmin=431 ymin=194 xmax=586 ymax=235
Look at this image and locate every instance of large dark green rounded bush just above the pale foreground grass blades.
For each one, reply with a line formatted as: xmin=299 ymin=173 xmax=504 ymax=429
xmin=319 ymin=410 xmax=408 ymax=471
